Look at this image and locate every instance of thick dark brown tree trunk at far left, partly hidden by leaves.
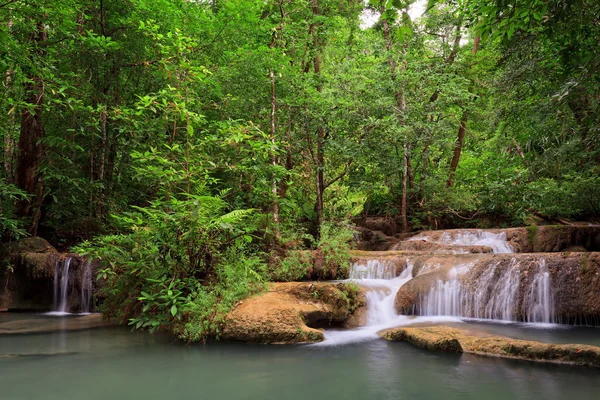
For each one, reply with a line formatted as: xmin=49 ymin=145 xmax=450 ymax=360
xmin=17 ymin=22 xmax=47 ymax=235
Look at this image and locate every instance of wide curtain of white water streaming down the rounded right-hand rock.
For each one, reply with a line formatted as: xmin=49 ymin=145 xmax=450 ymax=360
xmin=418 ymin=259 xmax=555 ymax=323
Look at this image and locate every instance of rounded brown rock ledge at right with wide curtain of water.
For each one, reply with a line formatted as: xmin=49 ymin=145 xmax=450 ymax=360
xmin=395 ymin=253 xmax=600 ymax=325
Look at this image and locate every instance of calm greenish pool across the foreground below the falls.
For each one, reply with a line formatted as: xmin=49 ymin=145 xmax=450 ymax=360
xmin=0 ymin=316 xmax=600 ymax=400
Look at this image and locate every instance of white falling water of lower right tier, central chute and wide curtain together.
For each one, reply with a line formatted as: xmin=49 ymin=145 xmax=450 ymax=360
xmin=322 ymin=250 xmax=555 ymax=346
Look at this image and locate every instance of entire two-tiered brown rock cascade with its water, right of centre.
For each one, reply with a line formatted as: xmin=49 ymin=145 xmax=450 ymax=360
xmin=324 ymin=227 xmax=600 ymax=344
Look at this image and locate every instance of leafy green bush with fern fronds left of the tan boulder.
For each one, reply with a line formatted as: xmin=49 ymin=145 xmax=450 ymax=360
xmin=76 ymin=195 xmax=264 ymax=341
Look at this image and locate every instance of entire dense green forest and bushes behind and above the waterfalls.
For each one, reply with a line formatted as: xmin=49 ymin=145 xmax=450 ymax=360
xmin=0 ymin=0 xmax=600 ymax=340
